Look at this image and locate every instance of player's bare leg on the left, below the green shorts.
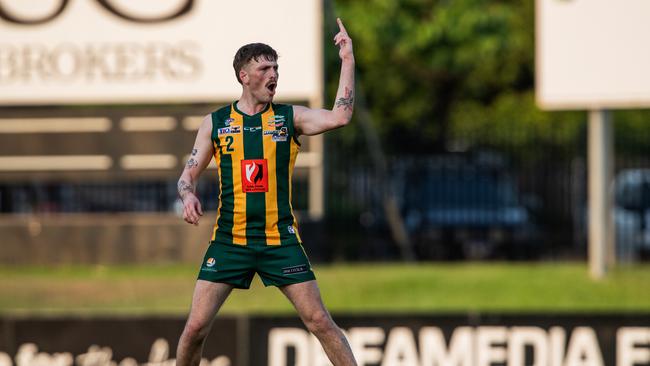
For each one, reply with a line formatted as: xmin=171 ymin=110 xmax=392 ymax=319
xmin=176 ymin=280 xmax=233 ymax=366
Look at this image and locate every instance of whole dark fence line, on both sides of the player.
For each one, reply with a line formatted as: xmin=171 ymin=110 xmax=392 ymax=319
xmin=0 ymin=115 xmax=650 ymax=261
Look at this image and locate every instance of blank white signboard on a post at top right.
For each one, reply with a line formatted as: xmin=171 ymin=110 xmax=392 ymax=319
xmin=536 ymin=0 xmax=650 ymax=109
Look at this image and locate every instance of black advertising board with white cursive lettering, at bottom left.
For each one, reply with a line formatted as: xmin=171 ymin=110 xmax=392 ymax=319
xmin=0 ymin=317 xmax=238 ymax=366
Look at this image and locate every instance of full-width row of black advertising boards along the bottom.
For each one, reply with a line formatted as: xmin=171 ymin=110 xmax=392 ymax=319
xmin=0 ymin=314 xmax=650 ymax=366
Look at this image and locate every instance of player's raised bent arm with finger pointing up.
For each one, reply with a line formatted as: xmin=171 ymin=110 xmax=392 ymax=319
xmin=293 ymin=18 xmax=354 ymax=136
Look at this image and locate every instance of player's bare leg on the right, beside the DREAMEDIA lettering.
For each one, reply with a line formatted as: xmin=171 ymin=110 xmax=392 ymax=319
xmin=280 ymin=281 xmax=357 ymax=366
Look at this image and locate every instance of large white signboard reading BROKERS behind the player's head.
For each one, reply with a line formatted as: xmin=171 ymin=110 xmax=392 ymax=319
xmin=0 ymin=0 xmax=322 ymax=105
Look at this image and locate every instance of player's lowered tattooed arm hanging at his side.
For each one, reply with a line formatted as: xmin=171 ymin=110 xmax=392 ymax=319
xmin=178 ymin=114 xmax=214 ymax=225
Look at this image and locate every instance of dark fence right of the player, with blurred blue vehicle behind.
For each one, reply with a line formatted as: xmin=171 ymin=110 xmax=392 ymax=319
xmin=326 ymin=116 xmax=650 ymax=261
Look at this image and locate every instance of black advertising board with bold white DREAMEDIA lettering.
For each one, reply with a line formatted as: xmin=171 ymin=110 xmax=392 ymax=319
xmin=251 ymin=315 xmax=650 ymax=366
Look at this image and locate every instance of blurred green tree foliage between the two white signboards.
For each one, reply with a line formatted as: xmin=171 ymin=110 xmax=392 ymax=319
xmin=326 ymin=0 xmax=585 ymax=153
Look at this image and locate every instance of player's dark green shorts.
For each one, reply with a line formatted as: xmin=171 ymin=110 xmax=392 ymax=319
xmin=199 ymin=242 xmax=316 ymax=289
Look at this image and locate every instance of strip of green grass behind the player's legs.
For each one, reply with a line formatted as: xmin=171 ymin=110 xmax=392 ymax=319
xmin=0 ymin=263 xmax=650 ymax=315
